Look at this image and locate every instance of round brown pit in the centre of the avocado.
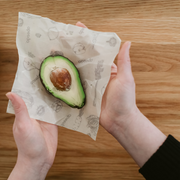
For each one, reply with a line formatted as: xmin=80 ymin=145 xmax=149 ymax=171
xmin=50 ymin=67 xmax=71 ymax=91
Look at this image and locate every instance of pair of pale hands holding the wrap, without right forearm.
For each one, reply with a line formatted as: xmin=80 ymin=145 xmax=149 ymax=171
xmin=7 ymin=22 xmax=137 ymax=179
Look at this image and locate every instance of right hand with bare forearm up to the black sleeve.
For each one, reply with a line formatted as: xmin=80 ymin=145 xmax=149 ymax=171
xmin=100 ymin=42 xmax=166 ymax=167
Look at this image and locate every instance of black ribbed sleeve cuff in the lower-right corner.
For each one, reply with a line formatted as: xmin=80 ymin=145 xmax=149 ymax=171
xmin=139 ymin=135 xmax=180 ymax=180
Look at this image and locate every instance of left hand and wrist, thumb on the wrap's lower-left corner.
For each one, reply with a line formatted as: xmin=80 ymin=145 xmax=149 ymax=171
xmin=6 ymin=93 xmax=58 ymax=180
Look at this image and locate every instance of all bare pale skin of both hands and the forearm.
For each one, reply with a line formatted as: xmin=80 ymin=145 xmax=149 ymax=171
xmin=7 ymin=22 xmax=166 ymax=180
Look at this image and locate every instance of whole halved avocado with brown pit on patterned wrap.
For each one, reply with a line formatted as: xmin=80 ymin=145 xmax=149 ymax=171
xmin=40 ymin=55 xmax=86 ymax=109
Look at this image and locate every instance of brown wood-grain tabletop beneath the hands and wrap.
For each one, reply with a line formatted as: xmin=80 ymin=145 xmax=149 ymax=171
xmin=0 ymin=0 xmax=180 ymax=180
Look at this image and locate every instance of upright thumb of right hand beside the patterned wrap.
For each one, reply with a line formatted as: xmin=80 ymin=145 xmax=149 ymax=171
xmin=117 ymin=41 xmax=133 ymax=79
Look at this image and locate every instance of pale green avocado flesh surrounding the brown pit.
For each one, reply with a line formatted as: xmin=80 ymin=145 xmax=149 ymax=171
xmin=40 ymin=55 xmax=86 ymax=109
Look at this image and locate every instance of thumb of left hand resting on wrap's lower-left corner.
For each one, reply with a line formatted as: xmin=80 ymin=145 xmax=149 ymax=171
xmin=6 ymin=92 xmax=30 ymax=122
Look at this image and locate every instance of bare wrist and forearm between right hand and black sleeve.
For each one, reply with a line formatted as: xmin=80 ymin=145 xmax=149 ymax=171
xmin=111 ymin=109 xmax=166 ymax=167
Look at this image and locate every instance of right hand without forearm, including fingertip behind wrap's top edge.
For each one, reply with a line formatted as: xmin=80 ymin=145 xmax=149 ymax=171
xmin=76 ymin=22 xmax=138 ymax=133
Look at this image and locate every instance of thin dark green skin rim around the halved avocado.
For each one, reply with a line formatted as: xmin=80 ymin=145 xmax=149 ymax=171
xmin=39 ymin=55 xmax=86 ymax=109
